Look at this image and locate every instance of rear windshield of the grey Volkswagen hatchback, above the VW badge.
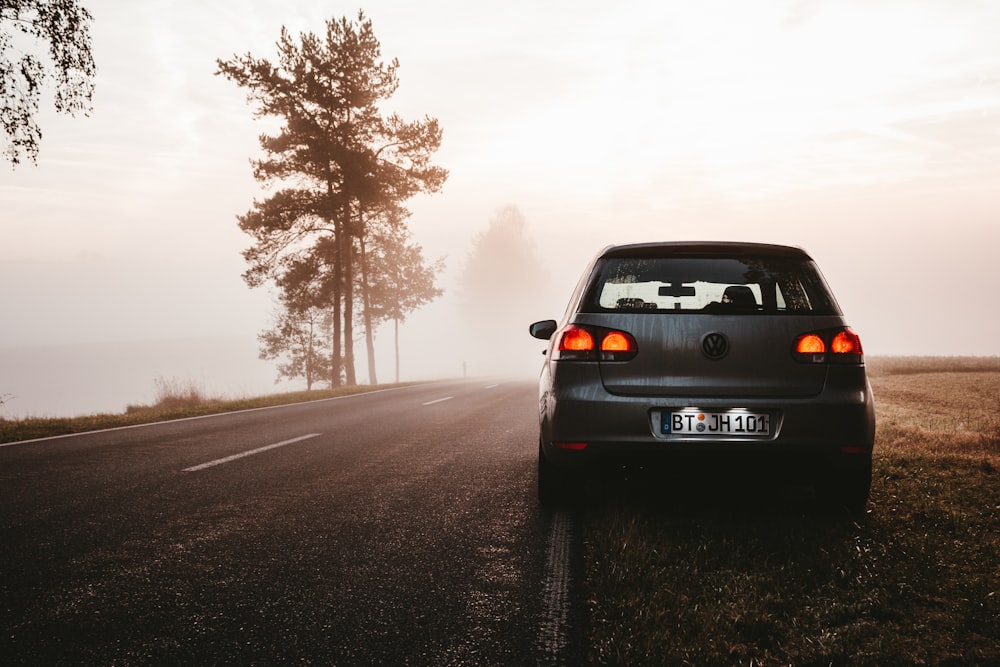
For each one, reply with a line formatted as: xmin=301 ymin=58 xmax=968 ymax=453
xmin=581 ymin=256 xmax=839 ymax=315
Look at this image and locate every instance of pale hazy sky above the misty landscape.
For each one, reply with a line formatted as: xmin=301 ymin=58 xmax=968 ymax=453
xmin=0 ymin=0 xmax=1000 ymax=414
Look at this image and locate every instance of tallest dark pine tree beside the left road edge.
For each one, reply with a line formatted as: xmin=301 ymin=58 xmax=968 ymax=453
xmin=223 ymin=12 xmax=447 ymax=385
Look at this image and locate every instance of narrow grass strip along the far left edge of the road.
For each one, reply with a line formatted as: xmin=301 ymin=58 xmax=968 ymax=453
xmin=0 ymin=378 xmax=412 ymax=443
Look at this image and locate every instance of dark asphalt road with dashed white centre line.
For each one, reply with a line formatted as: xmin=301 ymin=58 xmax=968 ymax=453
xmin=0 ymin=380 xmax=585 ymax=665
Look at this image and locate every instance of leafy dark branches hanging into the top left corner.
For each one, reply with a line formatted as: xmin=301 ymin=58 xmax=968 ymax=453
xmin=0 ymin=0 xmax=97 ymax=167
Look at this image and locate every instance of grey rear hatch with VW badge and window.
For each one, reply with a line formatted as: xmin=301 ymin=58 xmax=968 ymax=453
xmin=574 ymin=244 xmax=844 ymax=397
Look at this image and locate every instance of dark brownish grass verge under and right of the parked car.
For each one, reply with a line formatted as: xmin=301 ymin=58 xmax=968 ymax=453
xmin=581 ymin=359 xmax=1000 ymax=665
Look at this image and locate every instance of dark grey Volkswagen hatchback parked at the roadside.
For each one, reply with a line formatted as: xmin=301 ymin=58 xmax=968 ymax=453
xmin=529 ymin=242 xmax=875 ymax=513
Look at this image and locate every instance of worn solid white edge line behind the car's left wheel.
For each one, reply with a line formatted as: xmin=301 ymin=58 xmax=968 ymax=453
xmin=538 ymin=512 xmax=573 ymax=665
